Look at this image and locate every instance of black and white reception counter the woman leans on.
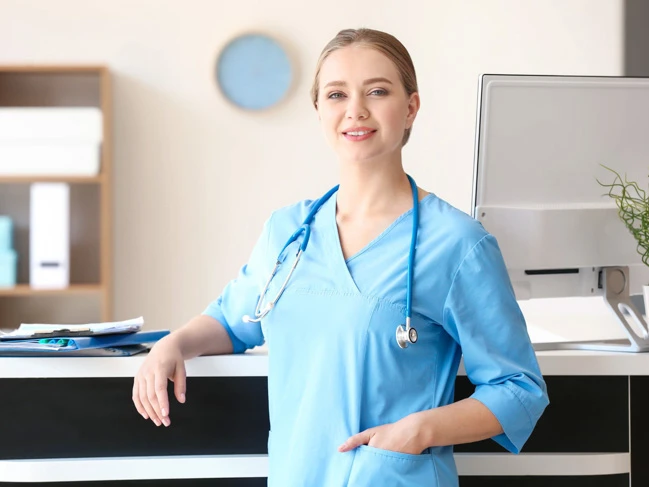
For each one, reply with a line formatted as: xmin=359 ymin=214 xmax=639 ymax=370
xmin=0 ymin=348 xmax=649 ymax=487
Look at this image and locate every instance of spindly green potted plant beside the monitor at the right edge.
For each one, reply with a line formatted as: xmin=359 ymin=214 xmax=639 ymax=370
xmin=597 ymin=164 xmax=649 ymax=315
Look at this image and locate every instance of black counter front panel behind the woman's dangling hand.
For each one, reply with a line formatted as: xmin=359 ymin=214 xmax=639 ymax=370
xmin=0 ymin=378 xmax=269 ymax=460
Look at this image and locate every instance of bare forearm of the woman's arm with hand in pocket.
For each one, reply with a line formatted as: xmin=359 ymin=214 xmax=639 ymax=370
xmin=412 ymin=398 xmax=503 ymax=447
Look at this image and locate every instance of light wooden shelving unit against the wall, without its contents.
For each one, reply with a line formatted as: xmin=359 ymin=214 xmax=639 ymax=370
xmin=0 ymin=65 xmax=113 ymax=328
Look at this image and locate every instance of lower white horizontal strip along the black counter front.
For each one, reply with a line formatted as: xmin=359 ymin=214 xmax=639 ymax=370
xmin=0 ymin=453 xmax=631 ymax=482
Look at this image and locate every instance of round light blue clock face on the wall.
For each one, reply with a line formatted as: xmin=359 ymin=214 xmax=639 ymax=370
xmin=216 ymin=34 xmax=292 ymax=110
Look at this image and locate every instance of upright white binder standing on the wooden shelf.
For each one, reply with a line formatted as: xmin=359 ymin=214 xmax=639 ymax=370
xmin=29 ymin=183 xmax=70 ymax=289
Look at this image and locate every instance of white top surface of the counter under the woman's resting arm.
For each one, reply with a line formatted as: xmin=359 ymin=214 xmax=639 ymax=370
xmin=0 ymin=348 xmax=649 ymax=378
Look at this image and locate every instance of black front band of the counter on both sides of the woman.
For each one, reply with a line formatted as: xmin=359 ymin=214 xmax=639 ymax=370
xmin=0 ymin=376 xmax=632 ymax=460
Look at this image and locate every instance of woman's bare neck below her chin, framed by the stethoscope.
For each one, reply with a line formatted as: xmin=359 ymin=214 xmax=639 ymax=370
xmin=336 ymin=155 xmax=412 ymax=217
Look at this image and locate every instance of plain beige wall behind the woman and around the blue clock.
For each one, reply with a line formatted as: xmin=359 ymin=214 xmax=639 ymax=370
xmin=0 ymin=0 xmax=623 ymax=328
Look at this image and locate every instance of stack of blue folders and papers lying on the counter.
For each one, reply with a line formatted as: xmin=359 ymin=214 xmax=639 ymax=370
xmin=0 ymin=317 xmax=169 ymax=357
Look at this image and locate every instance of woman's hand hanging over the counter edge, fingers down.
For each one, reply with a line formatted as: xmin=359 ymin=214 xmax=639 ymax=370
xmin=133 ymin=334 xmax=187 ymax=426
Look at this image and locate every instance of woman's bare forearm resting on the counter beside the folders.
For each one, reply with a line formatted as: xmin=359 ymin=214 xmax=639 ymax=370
xmin=163 ymin=315 xmax=233 ymax=360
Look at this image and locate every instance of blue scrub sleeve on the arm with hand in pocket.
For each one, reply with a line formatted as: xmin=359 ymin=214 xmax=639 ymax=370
xmin=443 ymin=234 xmax=549 ymax=453
